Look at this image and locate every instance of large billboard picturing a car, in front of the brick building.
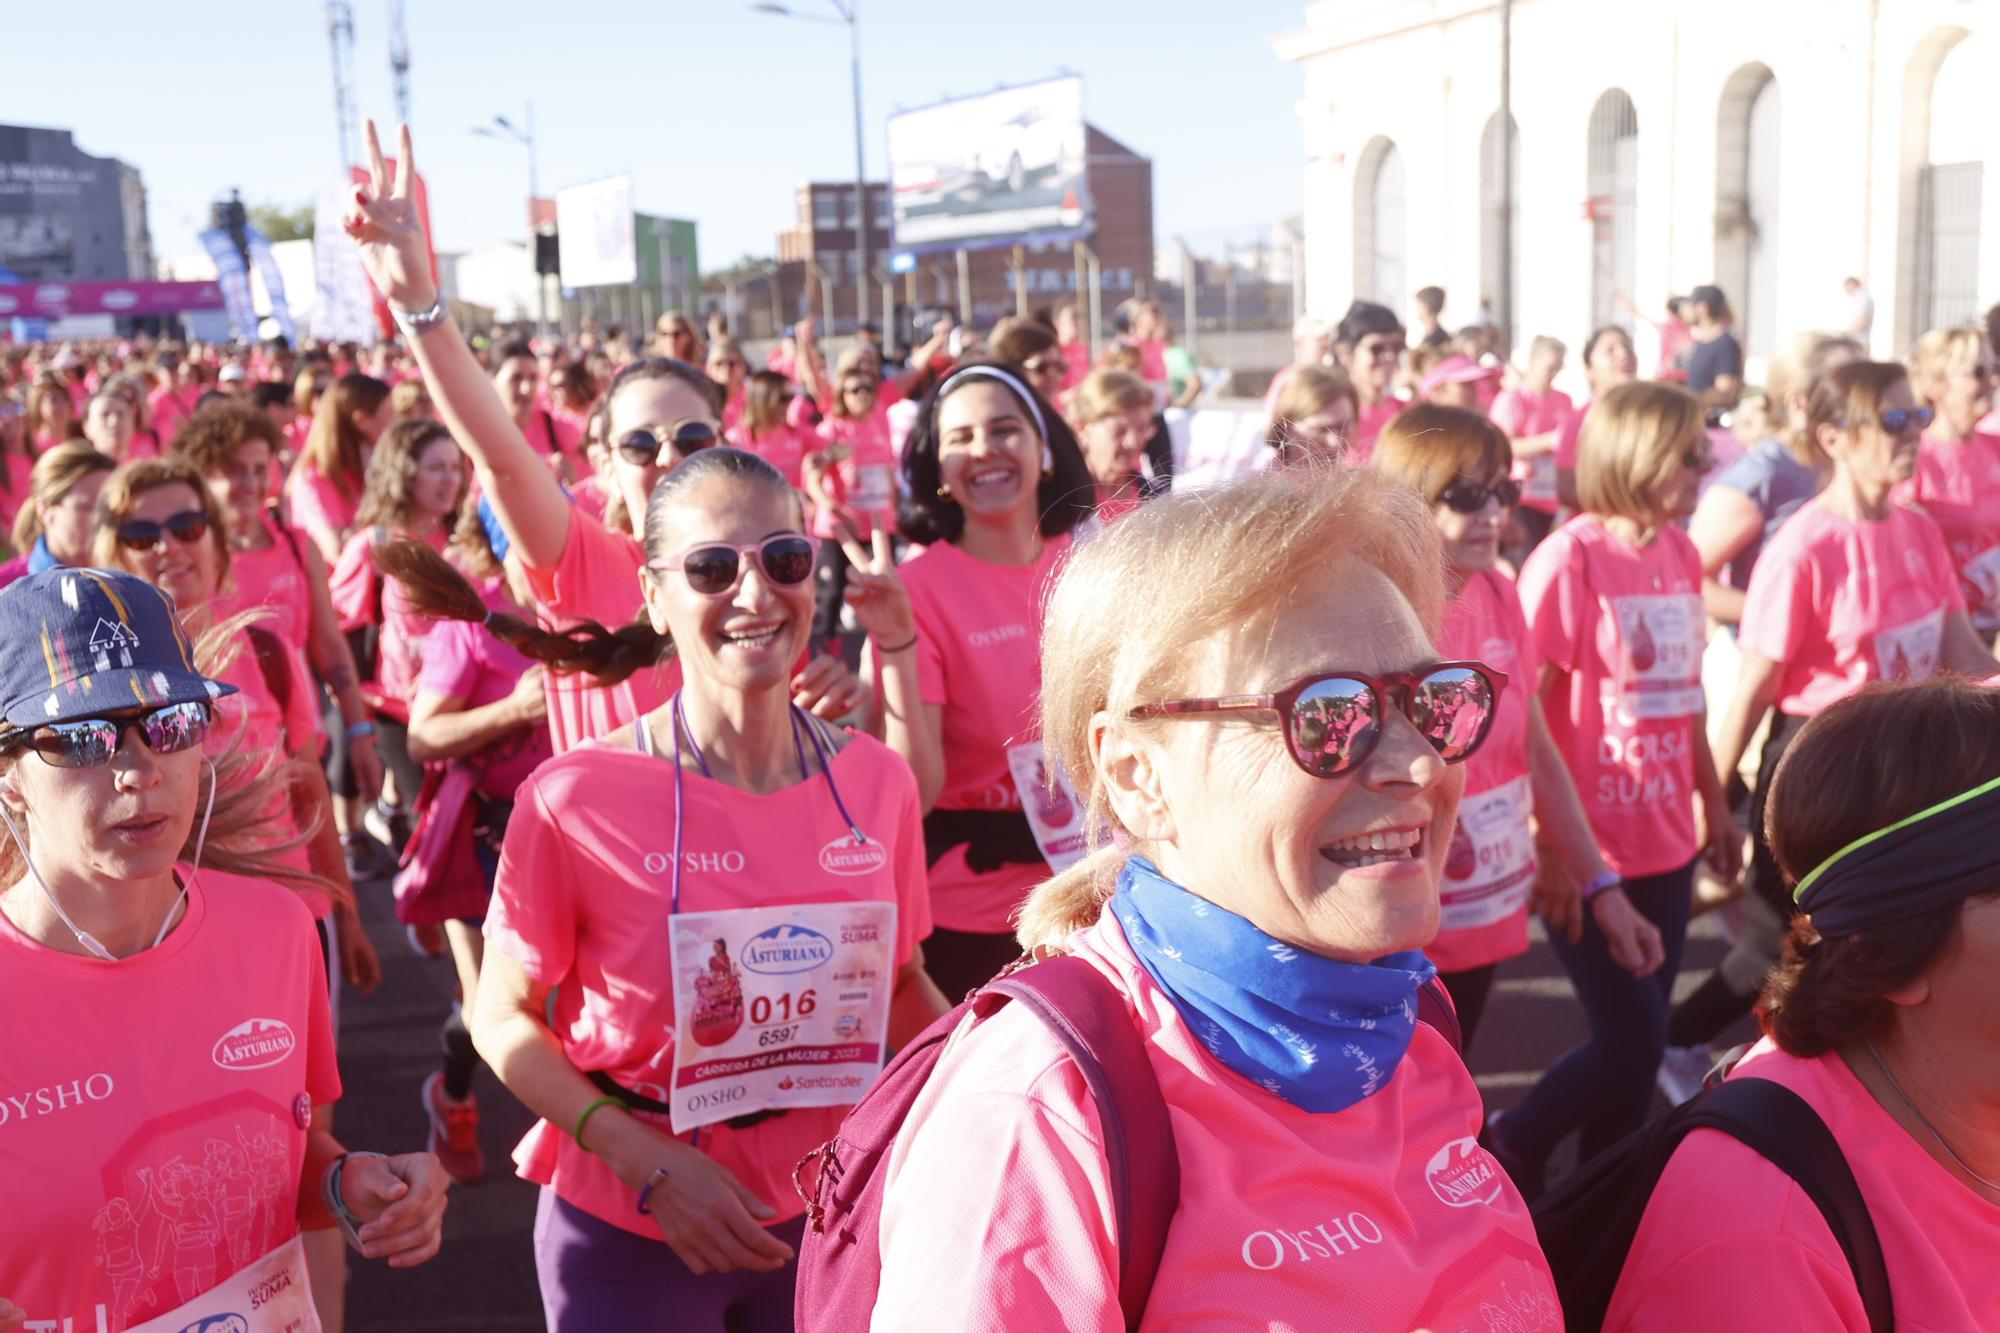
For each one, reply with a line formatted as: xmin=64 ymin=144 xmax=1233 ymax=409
xmin=888 ymin=78 xmax=1090 ymax=250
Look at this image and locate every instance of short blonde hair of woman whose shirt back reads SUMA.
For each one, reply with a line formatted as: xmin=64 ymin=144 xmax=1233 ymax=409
xmin=1576 ymin=380 xmax=1704 ymax=522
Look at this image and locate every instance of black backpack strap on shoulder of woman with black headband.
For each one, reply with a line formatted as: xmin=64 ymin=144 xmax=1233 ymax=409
xmin=1682 ymin=1077 xmax=1896 ymax=1333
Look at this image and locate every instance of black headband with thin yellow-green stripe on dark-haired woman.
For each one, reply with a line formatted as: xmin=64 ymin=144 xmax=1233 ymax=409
xmin=1792 ymin=779 xmax=2000 ymax=939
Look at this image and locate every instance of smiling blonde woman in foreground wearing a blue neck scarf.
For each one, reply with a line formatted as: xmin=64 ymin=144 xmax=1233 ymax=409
xmin=874 ymin=468 xmax=1560 ymax=1331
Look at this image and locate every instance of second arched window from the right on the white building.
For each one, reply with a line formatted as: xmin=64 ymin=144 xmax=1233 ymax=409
xmin=1716 ymin=64 xmax=1778 ymax=356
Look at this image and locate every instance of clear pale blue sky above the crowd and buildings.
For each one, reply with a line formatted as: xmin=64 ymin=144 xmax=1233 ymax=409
xmin=11 ymin=0 xmax=1304 ymax=268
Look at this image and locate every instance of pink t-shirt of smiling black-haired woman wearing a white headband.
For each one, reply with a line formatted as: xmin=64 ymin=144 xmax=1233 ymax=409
xmin=876 ymin=536 xmax=1070 ymax=935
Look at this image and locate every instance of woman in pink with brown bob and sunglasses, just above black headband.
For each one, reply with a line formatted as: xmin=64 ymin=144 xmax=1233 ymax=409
xmin=1716 ymin=360 xmax=2000 ymax=1016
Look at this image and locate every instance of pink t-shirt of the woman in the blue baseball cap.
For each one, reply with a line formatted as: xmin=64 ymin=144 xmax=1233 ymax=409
xmin=0 ymin=867 xmax=340 ymax=1333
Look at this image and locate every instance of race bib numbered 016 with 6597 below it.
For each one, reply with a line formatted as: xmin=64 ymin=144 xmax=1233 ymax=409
xmin=666 ymin=903 xmax=896 ymax=1135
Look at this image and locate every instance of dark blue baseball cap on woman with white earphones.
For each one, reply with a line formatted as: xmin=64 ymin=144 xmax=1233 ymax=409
xmin=0 ymin=568 xmax=236 ymax=727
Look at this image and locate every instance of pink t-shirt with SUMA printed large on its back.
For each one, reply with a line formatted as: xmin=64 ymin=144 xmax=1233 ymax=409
xmin=1520 ymin=514 xmax=1704 ymax=879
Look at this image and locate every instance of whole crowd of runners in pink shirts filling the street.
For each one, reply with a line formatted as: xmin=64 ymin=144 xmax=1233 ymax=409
xmin=0 ymin=116 xmax=2000 ymax=1333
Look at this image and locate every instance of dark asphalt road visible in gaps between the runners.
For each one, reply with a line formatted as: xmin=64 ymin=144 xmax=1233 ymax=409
xmin=336 ymin=856 xmax=1752 ymax=1333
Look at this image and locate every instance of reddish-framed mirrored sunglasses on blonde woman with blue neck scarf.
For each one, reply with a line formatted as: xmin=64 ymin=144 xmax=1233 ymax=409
xmin=1128 ymin=662 xmax=1506 ymax=779
